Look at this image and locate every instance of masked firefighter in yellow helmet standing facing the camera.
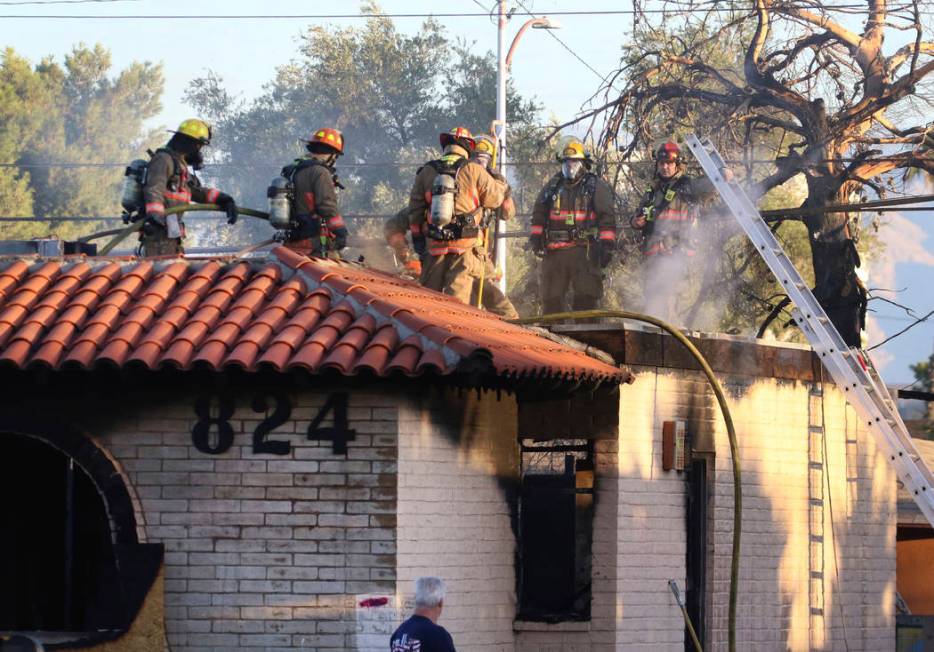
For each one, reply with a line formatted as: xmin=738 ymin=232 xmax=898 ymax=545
xmin=529 ymin=140 xmax=616 ymax=314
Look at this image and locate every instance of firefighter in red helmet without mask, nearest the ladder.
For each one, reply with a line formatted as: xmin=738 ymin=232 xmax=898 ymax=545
xmin=630 ymin=142 xmax=733 ymax=326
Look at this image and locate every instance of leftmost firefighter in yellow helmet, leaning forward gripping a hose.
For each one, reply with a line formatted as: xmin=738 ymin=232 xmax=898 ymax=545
xmin=139 ymin=119 xmax=238 ymax=256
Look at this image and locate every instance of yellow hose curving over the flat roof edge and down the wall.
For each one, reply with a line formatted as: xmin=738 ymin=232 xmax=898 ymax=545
xmin=511 ymin=310 xmax=743 ymax=652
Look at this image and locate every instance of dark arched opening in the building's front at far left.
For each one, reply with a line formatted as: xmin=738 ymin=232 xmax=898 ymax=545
xmin=0 ymin=433 xmax=125 ymax=632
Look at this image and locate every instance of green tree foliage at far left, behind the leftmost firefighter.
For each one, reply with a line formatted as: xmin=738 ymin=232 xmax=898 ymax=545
xmin=0 ymin=44 xmax=163 ymax=238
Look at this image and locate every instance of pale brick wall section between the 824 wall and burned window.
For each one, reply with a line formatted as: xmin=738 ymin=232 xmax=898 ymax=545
xmin=397 ymin=392 xmax=519 ymax=651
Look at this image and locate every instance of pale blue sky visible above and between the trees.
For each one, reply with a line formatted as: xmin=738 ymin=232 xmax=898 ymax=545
xmin=0 ymin=0 xmax=934 ymax=385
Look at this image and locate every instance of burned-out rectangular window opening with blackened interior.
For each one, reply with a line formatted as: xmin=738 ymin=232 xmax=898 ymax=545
xmin=517 ymin=439 xmax=594 ymax=623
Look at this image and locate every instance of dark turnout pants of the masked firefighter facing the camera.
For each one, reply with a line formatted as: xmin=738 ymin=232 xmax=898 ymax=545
xmin=541 ymin=246 xmax=603 ymax=315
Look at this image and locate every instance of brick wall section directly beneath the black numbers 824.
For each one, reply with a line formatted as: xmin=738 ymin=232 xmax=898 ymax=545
xmin=98 ymin=391 xmax=398 ymax=652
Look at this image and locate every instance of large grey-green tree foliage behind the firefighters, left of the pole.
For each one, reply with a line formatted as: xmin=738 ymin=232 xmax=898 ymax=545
xmin=186 ymin=5 xmax=539 ymax=263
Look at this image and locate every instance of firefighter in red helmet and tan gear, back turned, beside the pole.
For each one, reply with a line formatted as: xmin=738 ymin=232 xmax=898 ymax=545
xmin=409 ymin=127 xmax=509 ymax=303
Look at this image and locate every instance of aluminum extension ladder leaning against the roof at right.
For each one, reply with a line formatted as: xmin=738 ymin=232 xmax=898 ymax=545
xmin=686 ymin=134 xmax=934 ymax=526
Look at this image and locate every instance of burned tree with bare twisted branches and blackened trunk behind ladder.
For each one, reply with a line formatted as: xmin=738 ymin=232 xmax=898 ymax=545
xmin=581 ymin=0 xmax=934 ymax=345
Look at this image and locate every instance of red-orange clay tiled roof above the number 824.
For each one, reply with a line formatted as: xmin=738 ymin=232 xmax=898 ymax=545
xmin=0 ymin=248 xmax=628 ymax=385
